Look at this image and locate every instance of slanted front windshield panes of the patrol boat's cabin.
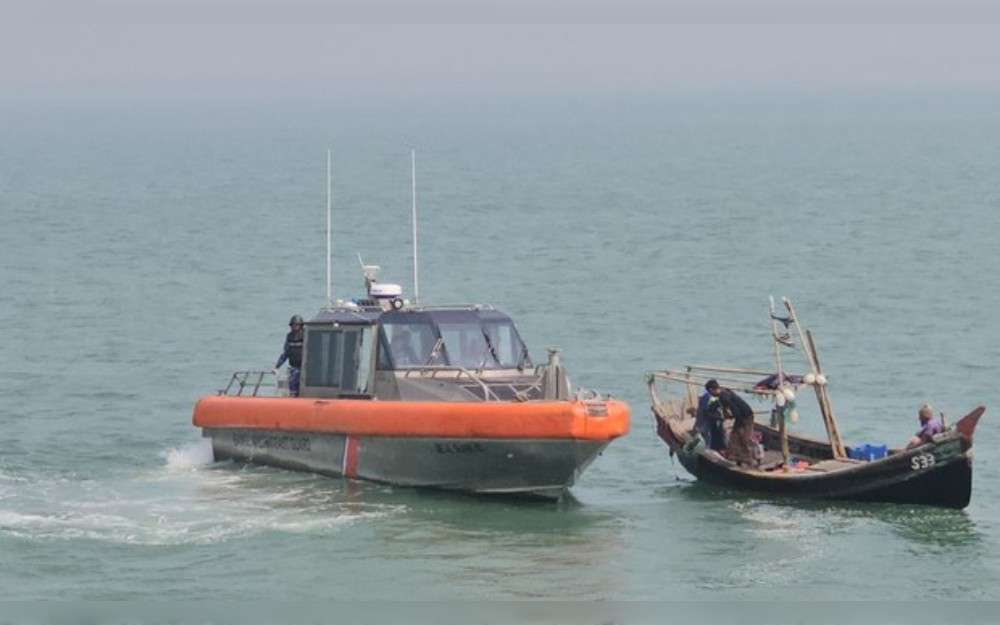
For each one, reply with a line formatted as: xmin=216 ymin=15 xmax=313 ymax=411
xmin=379 ymin=311 xmax=531 ymax=370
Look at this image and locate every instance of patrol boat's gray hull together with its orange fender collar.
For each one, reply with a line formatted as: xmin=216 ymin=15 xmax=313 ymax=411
xmin=193 ymin=397 xmax=629 ymax=499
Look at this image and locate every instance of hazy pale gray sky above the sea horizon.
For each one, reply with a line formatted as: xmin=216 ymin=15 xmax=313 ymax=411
xmin=0 ymin=0 xmax=1000 ymax=99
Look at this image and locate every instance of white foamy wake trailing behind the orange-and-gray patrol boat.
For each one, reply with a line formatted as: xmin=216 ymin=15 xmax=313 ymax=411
xmin=0 ymin=441 xmax=405 ymax=545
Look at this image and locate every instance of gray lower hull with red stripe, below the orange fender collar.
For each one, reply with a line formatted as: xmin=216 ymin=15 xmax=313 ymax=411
xmin=202 ymin=428 xmax=610 ymax=499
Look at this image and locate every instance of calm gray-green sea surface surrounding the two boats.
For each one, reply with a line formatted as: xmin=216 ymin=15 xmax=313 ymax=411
xmin=0 ymin=91 xmax=1000 ymax=600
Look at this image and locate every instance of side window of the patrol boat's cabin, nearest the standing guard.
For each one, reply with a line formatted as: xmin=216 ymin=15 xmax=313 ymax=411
xmin=303 ymin=326 xmax=374 ymax=396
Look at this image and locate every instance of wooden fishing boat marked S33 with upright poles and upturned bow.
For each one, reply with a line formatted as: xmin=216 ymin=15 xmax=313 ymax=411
xmin=647 ymin=299 xmax=985 ymax=509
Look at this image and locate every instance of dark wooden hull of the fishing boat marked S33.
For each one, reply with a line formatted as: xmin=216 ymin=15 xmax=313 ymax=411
xmin=654 ymin=409 xmax=982 ymax=509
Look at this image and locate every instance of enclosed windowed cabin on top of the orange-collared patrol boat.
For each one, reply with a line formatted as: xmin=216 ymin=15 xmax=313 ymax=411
xmin=299 ymin=301 xmax=541 ymax=401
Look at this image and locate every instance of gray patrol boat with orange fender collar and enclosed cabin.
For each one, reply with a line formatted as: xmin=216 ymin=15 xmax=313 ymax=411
xmin=193 ymin=258 xmax=630 ymax=499
